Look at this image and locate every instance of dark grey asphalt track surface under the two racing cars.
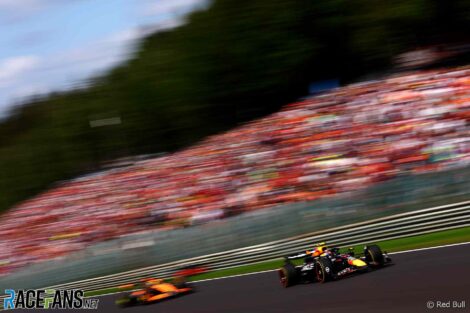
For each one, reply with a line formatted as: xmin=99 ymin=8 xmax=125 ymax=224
xmin=16 ymin=245 xmax=470 ymax=313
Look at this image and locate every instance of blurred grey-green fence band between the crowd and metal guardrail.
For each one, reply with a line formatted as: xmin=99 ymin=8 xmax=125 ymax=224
xmin=0 ymin=168 xmax=470 ymax=290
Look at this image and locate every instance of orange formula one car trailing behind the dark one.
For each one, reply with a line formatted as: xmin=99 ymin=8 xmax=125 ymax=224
xmin=116 ymin=277 xmax=194 ymax=307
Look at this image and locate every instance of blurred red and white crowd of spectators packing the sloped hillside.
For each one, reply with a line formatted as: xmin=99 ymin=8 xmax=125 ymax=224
xmin=0 ymin=67 xmax=470 ymax=274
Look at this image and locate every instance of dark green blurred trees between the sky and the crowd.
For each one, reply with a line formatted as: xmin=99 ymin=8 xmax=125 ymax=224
xmin=0 ymin=0 xmax=470 ymax=210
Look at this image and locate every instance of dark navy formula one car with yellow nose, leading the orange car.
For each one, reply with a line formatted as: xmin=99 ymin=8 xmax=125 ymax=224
xmin=278 ymin=243 xmax=392 ymax=288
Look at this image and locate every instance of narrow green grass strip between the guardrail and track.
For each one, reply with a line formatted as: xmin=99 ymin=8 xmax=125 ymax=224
xmin=85 ymin=227 xmax=470 ymax=297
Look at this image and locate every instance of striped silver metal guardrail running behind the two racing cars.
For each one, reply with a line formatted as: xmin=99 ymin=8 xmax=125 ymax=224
xmin=40 ymin=201 xmax=470 ymax=291
